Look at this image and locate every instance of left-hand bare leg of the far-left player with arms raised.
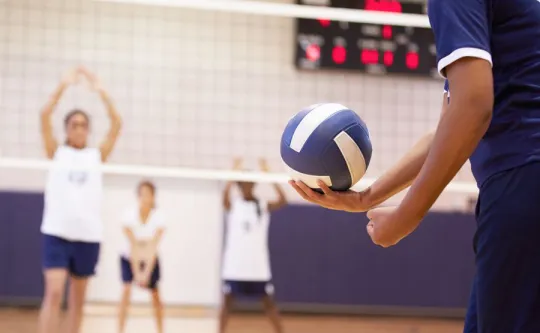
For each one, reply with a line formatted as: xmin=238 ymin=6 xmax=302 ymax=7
xmin=38 ymin=268 xmax=67 ymax=333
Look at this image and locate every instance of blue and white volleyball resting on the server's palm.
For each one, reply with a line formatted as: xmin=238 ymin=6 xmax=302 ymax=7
xmin=281 ymin=103 xmax=372 ymax=191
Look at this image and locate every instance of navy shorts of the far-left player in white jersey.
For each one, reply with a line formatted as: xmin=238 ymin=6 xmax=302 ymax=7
xmin=43 ymin=235 xmax=100 ymax=278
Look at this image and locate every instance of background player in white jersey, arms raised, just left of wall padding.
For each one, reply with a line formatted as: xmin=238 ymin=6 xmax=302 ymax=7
xmin=220 ymin=160 xmax=287 ymax=333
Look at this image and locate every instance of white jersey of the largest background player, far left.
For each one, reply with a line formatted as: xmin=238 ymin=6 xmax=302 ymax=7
xmin=41 ymin=146 xmax=103 ymax=243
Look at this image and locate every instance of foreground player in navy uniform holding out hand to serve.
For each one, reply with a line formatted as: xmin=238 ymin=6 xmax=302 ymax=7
xmin=291 ymin=0 xmax=540 ymax=333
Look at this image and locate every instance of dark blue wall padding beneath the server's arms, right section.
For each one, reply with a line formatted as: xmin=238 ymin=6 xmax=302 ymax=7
xmin=270 ymin=206 xmax=476 ymax=308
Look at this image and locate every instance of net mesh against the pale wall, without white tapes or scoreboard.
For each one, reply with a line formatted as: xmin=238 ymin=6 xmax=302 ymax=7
xmin=0 ymin=0 xmax=472 ymax=208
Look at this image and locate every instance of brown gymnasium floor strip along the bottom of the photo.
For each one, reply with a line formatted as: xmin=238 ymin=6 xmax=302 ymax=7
xmin=0 ymin=309 xmax=463 ymax=333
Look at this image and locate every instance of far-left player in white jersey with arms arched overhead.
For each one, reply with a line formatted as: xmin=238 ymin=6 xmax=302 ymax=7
xmin=38 ymin=68 xmax=121 ymax=333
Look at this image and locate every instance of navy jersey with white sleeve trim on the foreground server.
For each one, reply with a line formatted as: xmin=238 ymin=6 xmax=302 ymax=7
xmin=428 ymin=0 xmax=540 ymax=186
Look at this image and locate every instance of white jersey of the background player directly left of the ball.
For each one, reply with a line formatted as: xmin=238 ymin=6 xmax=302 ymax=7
xmin=222 ymin=198 xmax=272 ymax=282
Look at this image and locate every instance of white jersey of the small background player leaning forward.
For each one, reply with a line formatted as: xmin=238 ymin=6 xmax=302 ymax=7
xmin=120 ymin=206 xmax=165 ymax=259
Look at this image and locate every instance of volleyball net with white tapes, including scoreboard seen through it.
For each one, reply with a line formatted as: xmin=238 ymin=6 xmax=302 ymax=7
xmin=0 ymin=0 xmax=477 ymax=202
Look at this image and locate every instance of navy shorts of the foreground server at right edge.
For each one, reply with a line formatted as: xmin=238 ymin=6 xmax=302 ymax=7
xmin=464 ymin=163 xmax=540 ymax=333
